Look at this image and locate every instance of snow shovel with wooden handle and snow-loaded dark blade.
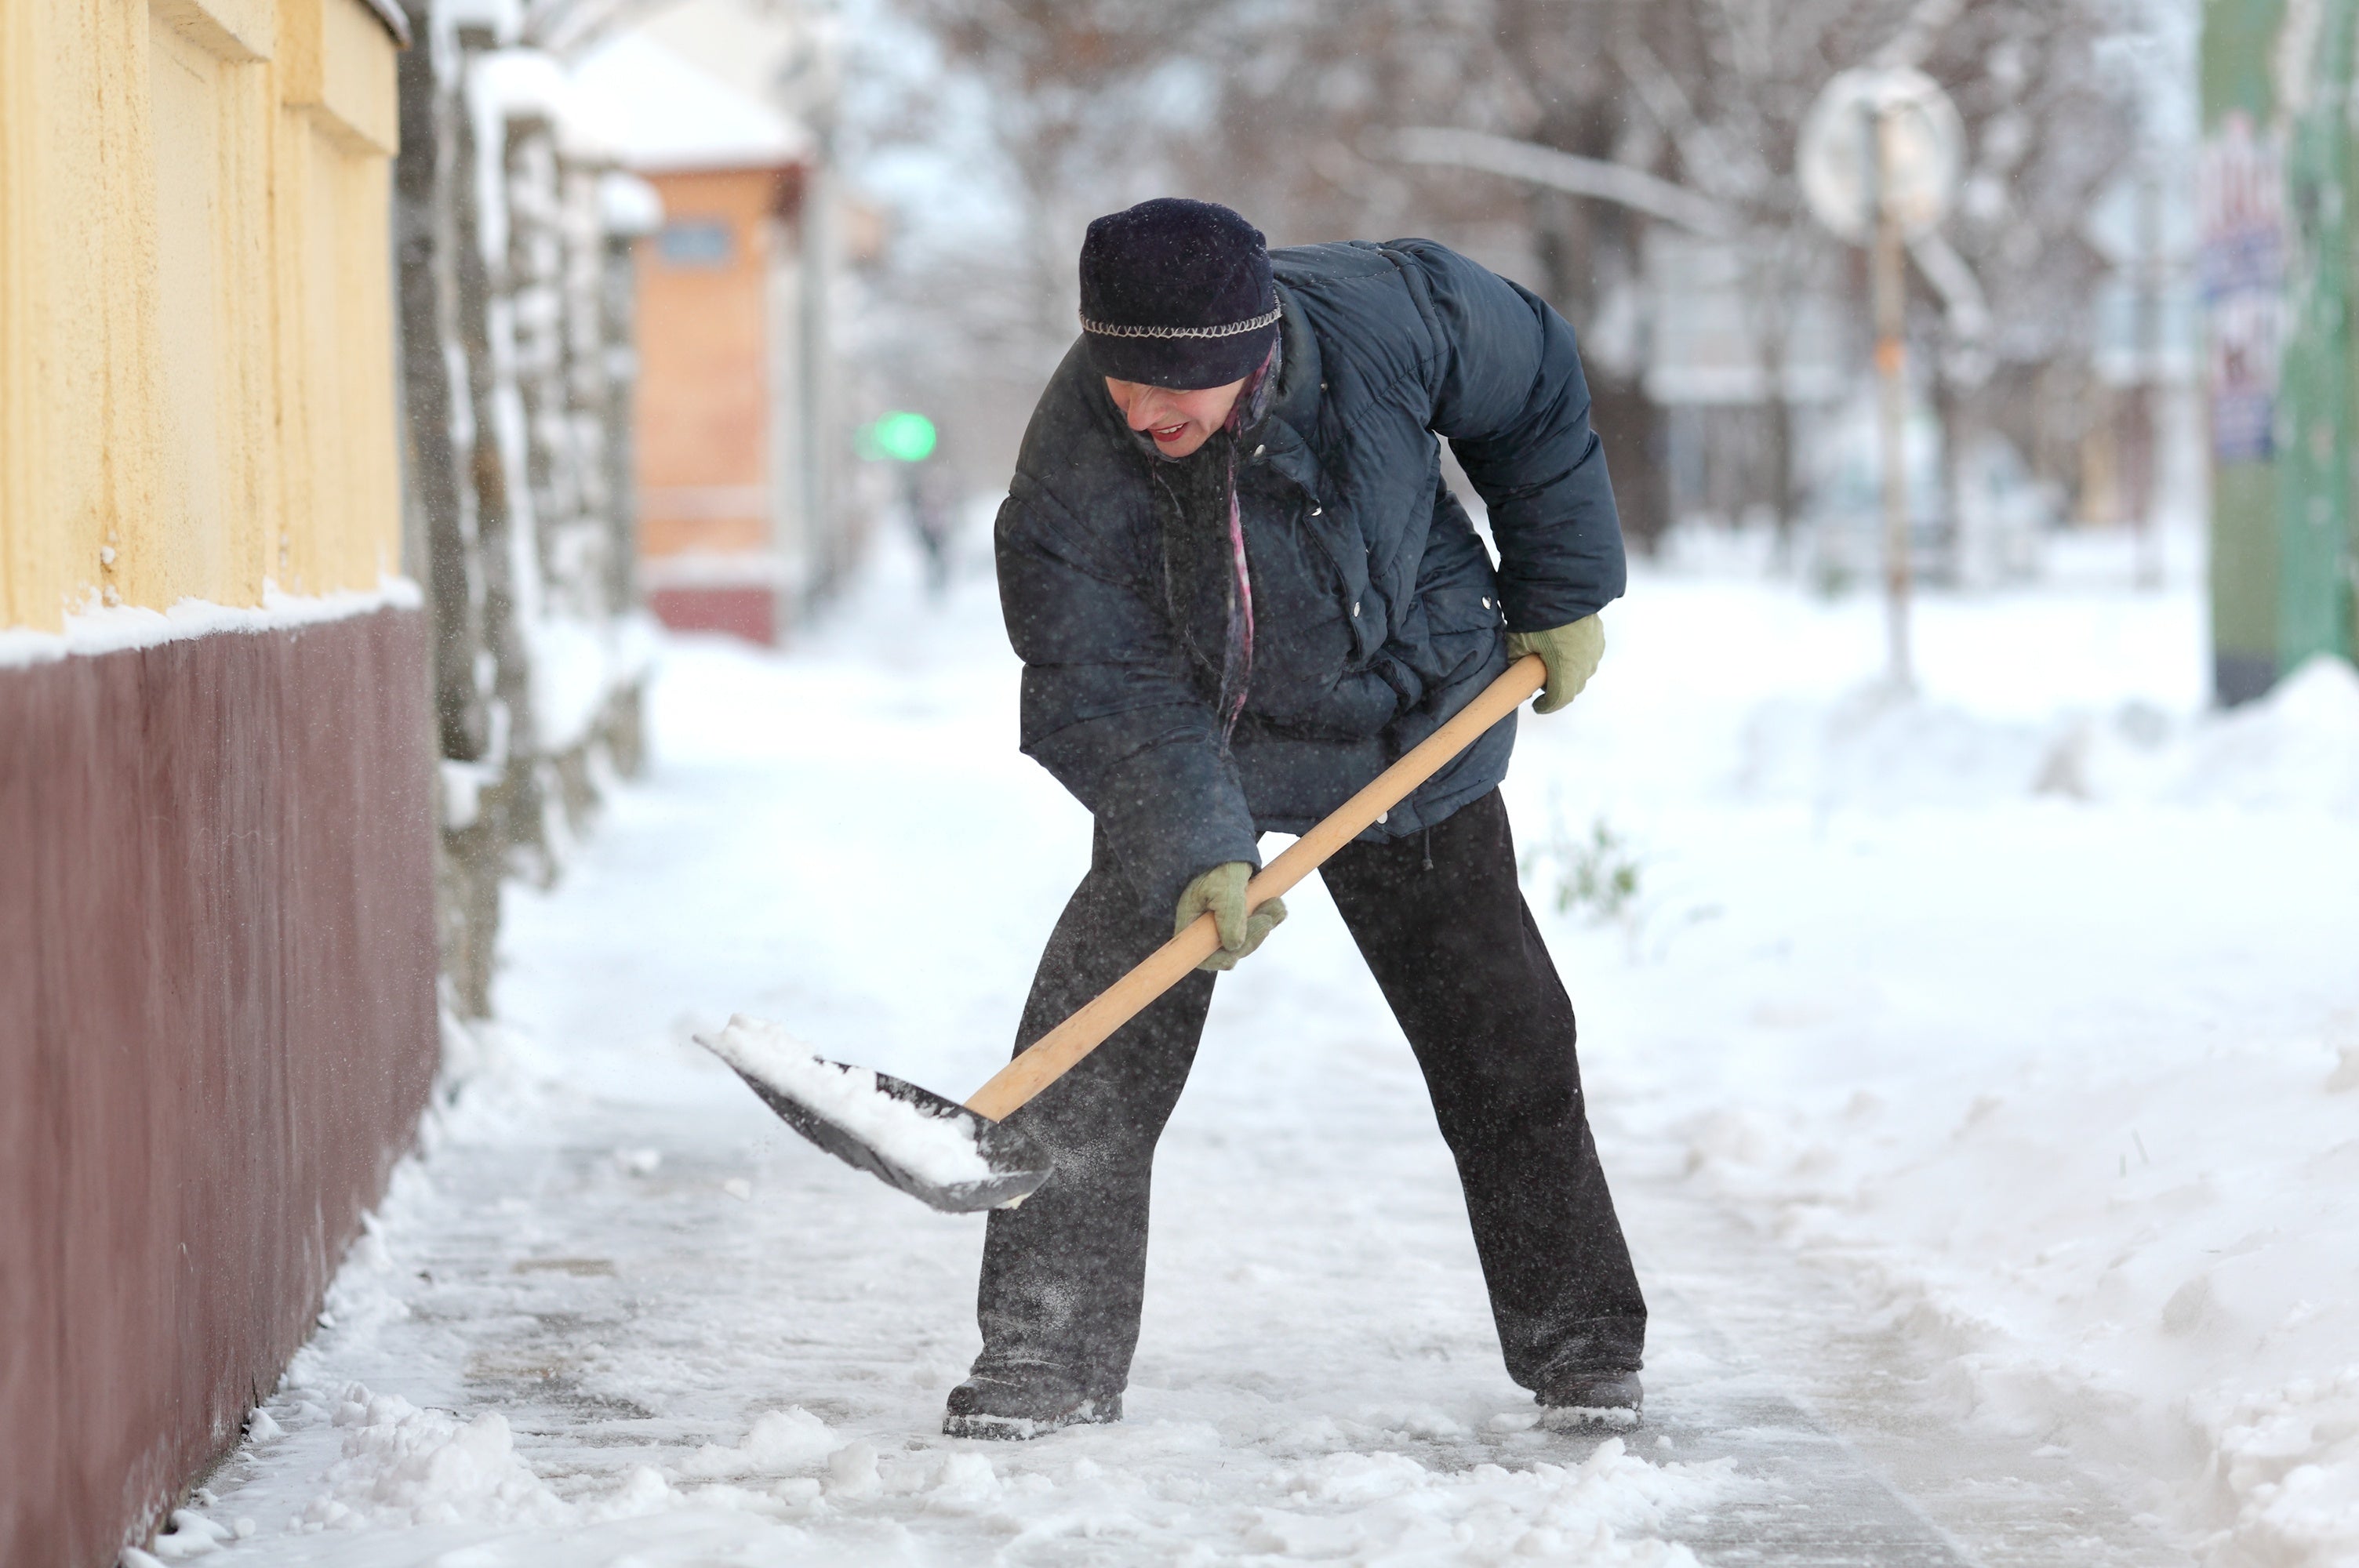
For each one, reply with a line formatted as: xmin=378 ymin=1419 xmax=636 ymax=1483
xmin=696 ymin=653 xmax=1547 ymax=1214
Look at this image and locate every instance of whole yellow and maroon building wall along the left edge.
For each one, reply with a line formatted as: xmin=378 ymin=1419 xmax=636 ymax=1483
xmin=0 ymin=0 xmax=436 ymax=1568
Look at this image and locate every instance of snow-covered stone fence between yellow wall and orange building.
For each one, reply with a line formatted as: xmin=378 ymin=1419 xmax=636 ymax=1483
xmin=394 ymin=0 xmax=656 ymax=1018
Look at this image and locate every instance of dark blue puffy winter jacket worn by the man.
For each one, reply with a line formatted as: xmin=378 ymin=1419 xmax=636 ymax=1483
xmin=998 ymin=241 xmax=1623 ymax=908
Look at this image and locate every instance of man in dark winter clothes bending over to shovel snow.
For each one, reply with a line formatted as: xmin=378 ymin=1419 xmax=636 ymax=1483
xmin=943 ymin=201 xmax=1647 ymax=1436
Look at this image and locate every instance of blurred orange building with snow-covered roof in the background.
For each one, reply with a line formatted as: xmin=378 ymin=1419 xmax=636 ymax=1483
xmin=578 ymin=0 xmax=856 ymax=644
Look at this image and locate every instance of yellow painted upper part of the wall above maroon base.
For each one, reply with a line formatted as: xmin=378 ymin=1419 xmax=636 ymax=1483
xmin=0 ymin=0 xmax=401 ymax=630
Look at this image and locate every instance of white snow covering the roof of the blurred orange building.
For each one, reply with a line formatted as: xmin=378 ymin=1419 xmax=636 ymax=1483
xmin=573 ymin=33 xmax=812 ymax=172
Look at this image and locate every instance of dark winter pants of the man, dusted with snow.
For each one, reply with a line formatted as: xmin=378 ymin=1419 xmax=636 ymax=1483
xmin=976 ymin=790 xmax=1647 ymax=1398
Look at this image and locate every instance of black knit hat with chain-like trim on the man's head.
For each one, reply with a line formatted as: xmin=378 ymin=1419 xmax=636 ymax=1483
xmin=1081 ymin=196 xmax=1278 ymax=391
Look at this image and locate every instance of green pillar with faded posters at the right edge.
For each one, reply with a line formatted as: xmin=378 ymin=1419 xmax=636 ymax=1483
xmin=2198 ymin=0 xmax=2359 ymax=702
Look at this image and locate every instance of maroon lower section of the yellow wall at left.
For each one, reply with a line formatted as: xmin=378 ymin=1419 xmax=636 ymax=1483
xmin=0 ymin=608 xmax=436 ymax=1568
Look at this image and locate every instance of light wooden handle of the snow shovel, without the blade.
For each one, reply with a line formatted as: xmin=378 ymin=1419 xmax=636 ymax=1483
xmin=967 ymin=653 xmax=1547 ymax=1120
